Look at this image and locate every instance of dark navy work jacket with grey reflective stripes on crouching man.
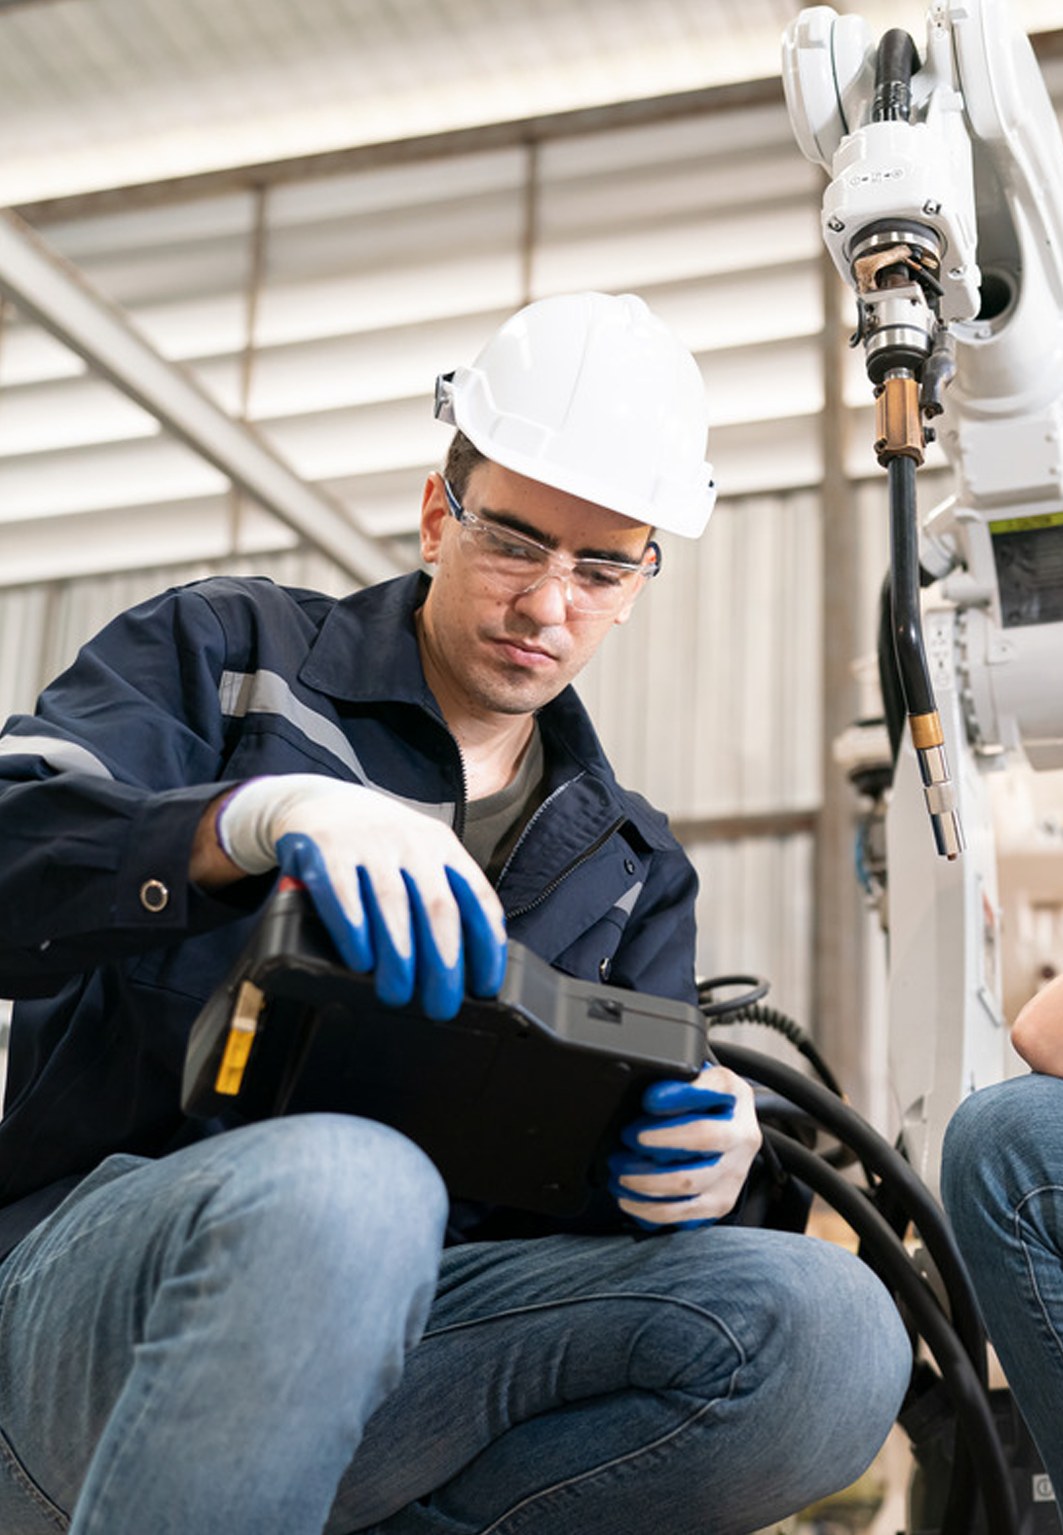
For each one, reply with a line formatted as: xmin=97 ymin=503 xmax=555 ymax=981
xmin=0 ymin=576 xmax=696 ymax=1256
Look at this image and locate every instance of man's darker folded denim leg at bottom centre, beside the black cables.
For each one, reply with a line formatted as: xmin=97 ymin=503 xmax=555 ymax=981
xmin=328 ymin=1226 xmax=911 ymax=1535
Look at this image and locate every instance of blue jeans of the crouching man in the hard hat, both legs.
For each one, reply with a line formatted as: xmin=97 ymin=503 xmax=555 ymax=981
xmin=0 ymin=1114 xmax=910 ymax=1535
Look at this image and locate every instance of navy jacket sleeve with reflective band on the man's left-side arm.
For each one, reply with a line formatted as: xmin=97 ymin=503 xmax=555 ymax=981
xmin=0 ymin=591 xmax=261 ymax=996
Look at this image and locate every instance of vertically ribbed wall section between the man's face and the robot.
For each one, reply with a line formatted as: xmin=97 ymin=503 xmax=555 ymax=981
xmin=581 ymin=493 xmax=821 ymax=1019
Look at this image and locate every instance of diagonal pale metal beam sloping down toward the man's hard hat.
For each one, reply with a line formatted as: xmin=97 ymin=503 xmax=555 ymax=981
xmin=0 ymin=209 xmax=405 ymax=583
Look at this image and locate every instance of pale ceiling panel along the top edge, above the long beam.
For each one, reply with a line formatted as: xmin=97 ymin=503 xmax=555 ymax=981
xmin=0 ymin=0 xmax=1061 ymax=206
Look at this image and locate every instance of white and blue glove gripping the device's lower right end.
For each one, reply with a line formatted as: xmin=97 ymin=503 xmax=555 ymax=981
xmin=609 ymin=1065 xmax=761 ymax=1230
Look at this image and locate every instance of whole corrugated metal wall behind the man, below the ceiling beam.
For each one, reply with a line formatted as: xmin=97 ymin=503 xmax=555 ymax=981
xmin=0 ymin=87 xmax=963 ymax=1092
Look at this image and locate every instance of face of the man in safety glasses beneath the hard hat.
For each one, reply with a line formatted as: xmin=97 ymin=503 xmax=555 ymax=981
xmin=420 ymin=462 xmax=650 ymax=714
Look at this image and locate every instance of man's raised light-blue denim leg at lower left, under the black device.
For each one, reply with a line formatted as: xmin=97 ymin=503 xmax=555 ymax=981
xmin=0 ymin=1114 xmax=446 ymax=1535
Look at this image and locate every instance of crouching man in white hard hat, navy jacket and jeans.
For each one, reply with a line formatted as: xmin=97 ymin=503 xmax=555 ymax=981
xmin=0 ymin=295 xmax=910 ymax=1535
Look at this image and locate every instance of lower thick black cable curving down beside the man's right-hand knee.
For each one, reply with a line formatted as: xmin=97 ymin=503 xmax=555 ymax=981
xmin=764 ymin=1128 xmax=1019 ymax=1535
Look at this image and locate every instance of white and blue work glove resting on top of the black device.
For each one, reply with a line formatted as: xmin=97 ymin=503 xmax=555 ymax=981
xmin=216 ymin=774 xmax=506 ymax=1019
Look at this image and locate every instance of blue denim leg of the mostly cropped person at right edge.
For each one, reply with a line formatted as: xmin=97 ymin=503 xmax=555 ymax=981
xmin=942 ymin=1075 xmax=1063 ymax=1503
